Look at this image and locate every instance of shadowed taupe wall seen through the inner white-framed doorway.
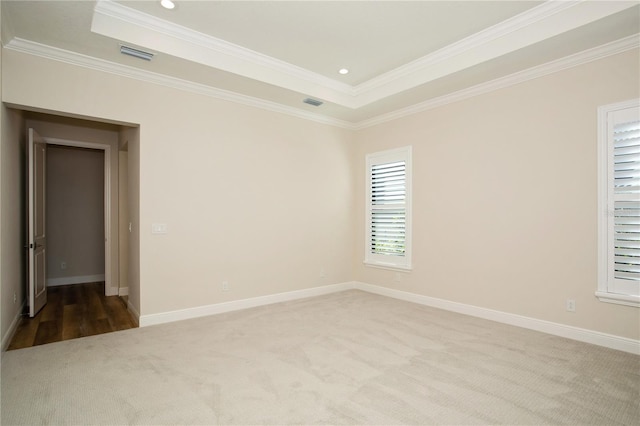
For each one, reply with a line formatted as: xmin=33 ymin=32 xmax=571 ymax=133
xmin=46 ymin=145 xmax=105 ymax=285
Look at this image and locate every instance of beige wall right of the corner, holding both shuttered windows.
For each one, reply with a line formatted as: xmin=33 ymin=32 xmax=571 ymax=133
xmin=355 ymin=51 xmax=640 ymax=339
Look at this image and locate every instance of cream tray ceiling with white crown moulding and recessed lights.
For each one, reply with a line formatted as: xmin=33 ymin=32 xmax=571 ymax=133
xmin=1 ymin=0 xmax=640 ymax=127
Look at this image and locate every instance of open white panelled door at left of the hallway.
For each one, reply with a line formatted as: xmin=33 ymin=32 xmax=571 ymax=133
xmin=27 ymin=129 xmax=47 ymax=318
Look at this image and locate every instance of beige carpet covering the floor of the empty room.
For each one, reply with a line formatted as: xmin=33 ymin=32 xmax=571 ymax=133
xmin=1 ymin=290 xmax=640 ymax=425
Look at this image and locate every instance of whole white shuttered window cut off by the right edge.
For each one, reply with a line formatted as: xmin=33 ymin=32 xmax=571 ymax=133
xmin=596 ymin=100 xmax=640 ymax=306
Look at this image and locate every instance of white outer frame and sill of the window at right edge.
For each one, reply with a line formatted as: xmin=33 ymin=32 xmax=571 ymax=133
xmin=595 ymin=99 xmax=640 ymax=307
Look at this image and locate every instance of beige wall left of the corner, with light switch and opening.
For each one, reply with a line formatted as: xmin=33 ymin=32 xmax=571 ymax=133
xmin=3 ymin=51 xmax=354 ymax=315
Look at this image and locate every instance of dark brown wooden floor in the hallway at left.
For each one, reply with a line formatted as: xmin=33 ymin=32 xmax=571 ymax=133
xmin=7 ymin=282 xmax=137 ymax=350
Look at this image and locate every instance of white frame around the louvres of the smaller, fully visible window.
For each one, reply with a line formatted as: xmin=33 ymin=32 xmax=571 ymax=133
xmin=364 ymin=146 xmax=413 ymax=271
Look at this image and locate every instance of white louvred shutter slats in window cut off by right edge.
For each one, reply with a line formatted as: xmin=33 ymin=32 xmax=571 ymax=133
xmin=613 ymin=119 xmax=640 ymax=281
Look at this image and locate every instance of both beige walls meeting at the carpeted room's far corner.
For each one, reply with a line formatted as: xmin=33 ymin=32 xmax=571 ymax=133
xmin=3 ymin=43 xmax=640 ymax=339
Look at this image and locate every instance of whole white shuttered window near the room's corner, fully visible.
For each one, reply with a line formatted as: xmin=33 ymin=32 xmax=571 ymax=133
xmin=364 ymin=146 xmax=411 ymax=269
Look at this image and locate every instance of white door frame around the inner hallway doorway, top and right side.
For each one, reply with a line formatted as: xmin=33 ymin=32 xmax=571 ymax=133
xmin=42 ymin=136 xmax=119 ymax=296
